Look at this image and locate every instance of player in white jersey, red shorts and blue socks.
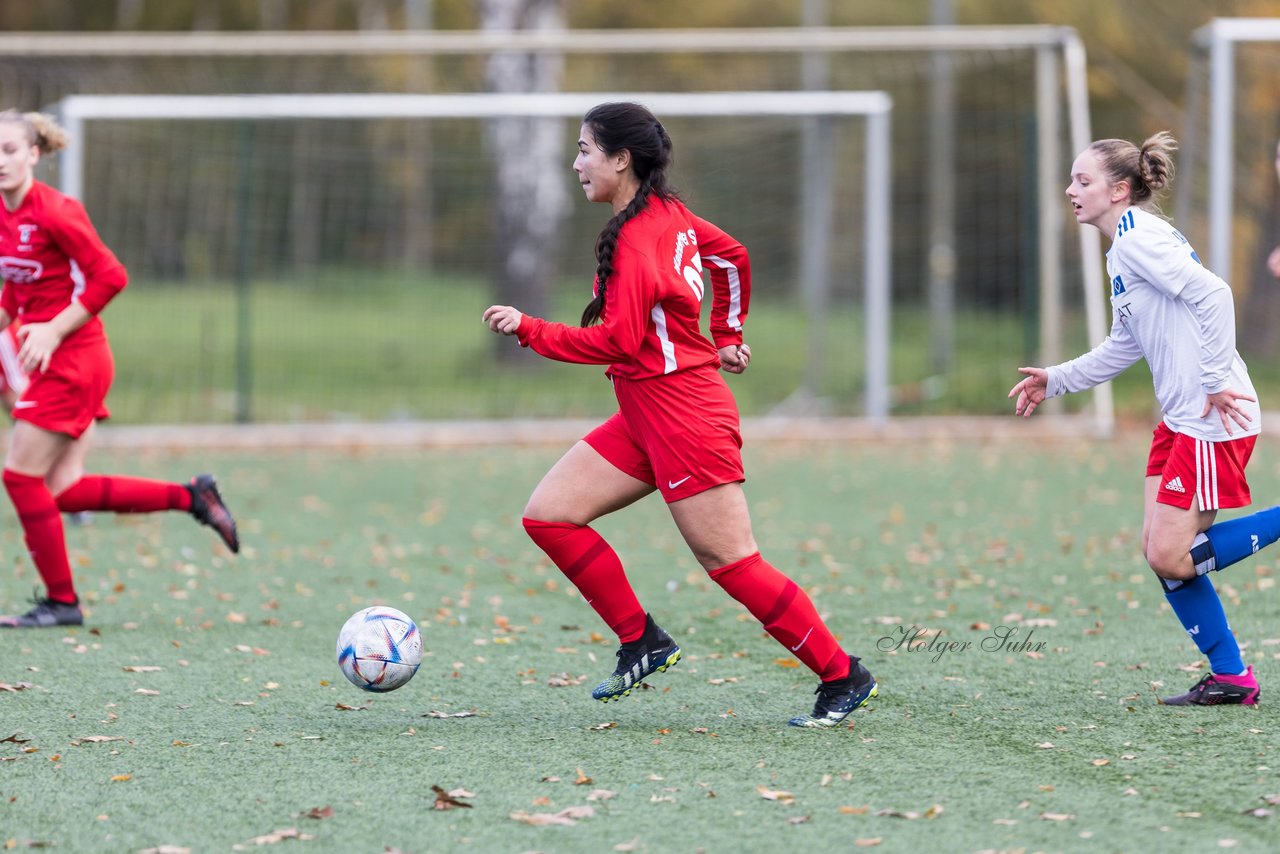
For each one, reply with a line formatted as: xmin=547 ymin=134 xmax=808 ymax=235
xmin=1009 ymin=133 xmax=1280 ymax=705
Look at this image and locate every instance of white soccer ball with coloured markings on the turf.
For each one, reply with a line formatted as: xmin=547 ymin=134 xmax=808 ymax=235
xmin=338 ymin=606 xmax=422 ymax=691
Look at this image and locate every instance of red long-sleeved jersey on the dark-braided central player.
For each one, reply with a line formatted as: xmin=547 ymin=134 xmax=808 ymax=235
xmin=516 ymin=197 xmax=751 ymax=379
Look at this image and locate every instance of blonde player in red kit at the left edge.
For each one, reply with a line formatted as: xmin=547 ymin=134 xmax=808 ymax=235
xmin=0 ymin=110 xmax=239 ymax=627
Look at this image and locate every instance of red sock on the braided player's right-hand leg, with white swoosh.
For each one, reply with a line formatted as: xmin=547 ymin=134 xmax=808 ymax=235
xmin=710 ymin=552 xmax=849 ymax=682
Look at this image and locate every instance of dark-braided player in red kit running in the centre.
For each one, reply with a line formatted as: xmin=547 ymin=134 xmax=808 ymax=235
xmin=484 ymin=102 xmax=877 ymax=727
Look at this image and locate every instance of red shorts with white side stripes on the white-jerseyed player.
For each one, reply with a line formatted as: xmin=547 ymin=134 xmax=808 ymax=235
xmin=1147 ymin=421 xmax=1258 ymax=510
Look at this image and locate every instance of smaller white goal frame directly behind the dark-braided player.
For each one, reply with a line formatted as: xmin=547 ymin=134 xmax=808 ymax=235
xmin=52 ymin=91 xmax=892 ymax=421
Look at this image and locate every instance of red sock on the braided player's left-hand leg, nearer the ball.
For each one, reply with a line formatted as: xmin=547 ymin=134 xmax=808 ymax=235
xmin=522 ymin=519 xmax=645 ymax=643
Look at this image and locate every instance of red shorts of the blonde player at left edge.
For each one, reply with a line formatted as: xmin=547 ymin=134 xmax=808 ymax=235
xmin=13 ymin=339 xmax=115 ymax=439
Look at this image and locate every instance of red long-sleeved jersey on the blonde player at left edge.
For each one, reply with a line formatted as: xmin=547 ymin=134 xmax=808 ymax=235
xmin=0 ymin=181 xmax=128 ymax=346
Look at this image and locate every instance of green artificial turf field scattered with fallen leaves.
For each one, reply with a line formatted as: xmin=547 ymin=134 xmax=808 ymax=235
xmin=0 ymin=433 xmax=1280 ymax=853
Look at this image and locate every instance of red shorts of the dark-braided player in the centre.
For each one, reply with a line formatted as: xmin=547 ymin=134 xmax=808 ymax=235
xmin=582 ymin=370 xmax=746 ymax=503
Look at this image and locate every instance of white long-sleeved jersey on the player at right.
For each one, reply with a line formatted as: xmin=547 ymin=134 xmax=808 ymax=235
xmin=1046 ymin=207 xmax=1262 ymax=442
